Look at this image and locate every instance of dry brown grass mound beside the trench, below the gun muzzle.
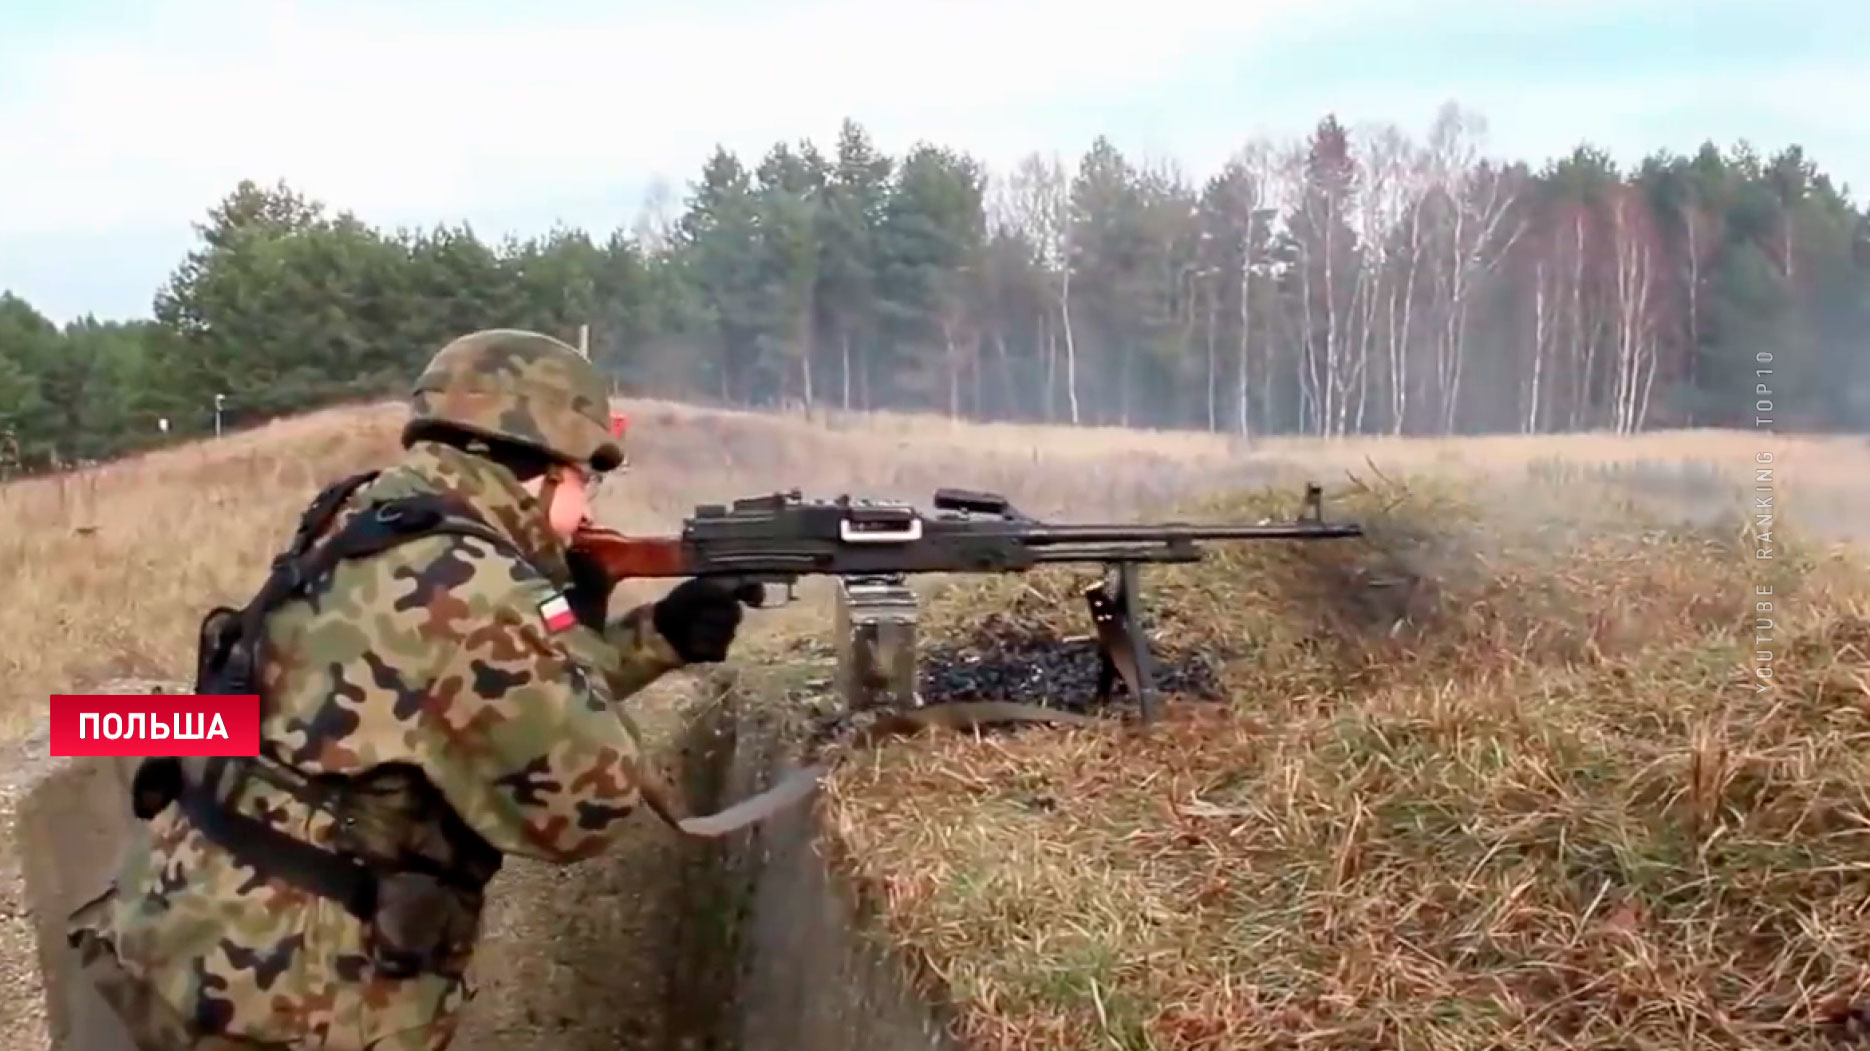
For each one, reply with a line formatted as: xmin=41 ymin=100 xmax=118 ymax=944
xmin=828 ymin=467 xmax=1870 ymax=1051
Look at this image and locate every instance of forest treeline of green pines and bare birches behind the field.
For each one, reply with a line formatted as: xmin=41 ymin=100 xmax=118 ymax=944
xmin=0 ymin=105 xmax=1870 ymax=469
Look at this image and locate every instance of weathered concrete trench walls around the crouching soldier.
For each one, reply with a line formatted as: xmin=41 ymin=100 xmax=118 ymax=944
xmin=0 ymin=675 xmax=959 ymax=1051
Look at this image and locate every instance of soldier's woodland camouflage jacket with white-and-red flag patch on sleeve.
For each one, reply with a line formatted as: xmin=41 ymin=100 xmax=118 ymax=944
xmin=73 ymin=443 xmax=695 ymax=1049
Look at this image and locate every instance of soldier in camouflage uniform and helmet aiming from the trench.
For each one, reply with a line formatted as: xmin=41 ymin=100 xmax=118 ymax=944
xmin=71 ymin=331 xmax=744 ymax=1051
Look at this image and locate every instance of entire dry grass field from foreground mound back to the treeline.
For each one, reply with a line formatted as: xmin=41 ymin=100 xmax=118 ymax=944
xmin=0 ymin=402 xmax=1870 ymax=1051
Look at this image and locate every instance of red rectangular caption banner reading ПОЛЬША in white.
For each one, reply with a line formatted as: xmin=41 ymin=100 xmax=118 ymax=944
xmin=50 ymin=694 xmax=260 ymax=756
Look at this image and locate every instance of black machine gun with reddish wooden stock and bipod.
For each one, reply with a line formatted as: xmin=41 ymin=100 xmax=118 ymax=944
xmin=572 ymin=484 xmax=1363 ymax=724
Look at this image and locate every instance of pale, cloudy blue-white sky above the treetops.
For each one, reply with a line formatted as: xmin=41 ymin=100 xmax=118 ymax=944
xmin=0 ymin=0 xmax=1870 ymax=322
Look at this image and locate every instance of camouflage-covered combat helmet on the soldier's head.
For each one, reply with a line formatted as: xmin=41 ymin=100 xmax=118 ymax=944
xmin=402 ymin=329 xmax=623 ymax=471
